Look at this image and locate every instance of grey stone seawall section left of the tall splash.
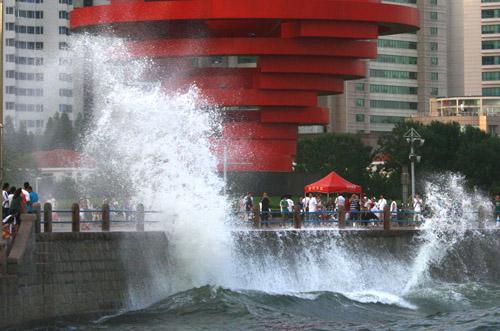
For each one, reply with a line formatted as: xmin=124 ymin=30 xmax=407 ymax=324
xmin=0 ymin=232 xmax=168 ymax=327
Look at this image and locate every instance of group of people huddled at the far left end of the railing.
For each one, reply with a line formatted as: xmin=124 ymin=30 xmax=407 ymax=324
xmin=2 ymin=182 xmax=39 ymax=239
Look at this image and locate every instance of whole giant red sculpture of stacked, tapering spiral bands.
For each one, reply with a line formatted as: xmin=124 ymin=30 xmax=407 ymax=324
xmin=71 ymin=0 xmax=418 ymax=172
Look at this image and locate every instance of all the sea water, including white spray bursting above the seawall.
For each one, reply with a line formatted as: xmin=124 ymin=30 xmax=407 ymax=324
xmin=15 ymin=35 xmax=500 ymax=330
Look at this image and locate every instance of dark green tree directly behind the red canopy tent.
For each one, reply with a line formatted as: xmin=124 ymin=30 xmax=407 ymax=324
xmin=295 ymin=133 xmax=371 ymax=185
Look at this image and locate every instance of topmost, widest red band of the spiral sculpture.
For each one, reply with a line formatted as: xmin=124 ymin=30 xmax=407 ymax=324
xmin=71 ymin=0 xmax=419 ymax=32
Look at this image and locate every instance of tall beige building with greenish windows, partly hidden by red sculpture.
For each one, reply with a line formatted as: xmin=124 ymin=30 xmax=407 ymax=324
xmin=321 ymin=0 xmax=448 ymax=144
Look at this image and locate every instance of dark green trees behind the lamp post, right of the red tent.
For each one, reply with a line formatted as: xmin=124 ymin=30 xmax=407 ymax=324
xmin=378 ymin=122 xmax=500 ymax=195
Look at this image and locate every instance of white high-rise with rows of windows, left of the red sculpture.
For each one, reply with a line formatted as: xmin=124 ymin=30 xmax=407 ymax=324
xmin=3 ymin=0 xmax=75 ymax=133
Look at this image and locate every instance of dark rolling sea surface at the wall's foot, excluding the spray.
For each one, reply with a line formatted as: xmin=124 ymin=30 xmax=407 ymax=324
xmin=14 ymin=264 xmax=500 ymax=330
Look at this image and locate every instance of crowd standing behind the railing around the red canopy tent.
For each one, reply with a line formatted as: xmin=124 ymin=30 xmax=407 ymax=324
xmin=240 ymin=192 xmax=424 ymax=224
